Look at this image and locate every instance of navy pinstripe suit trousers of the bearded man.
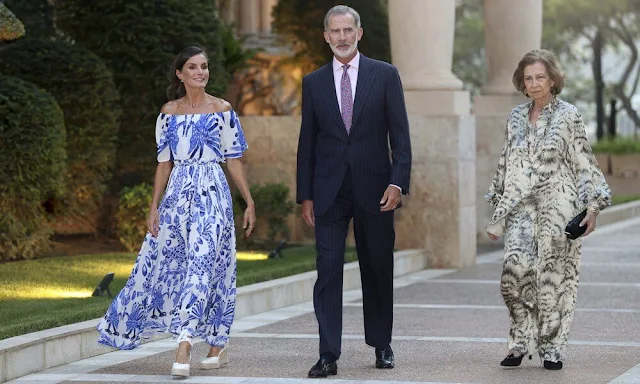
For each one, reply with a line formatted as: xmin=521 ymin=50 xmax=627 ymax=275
xmin=313 ymin=169 xmax=395 ymax=358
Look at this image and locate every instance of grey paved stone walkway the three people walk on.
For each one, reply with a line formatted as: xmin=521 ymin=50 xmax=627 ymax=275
xmin=12 ymin=214 xmax=640 ymax=384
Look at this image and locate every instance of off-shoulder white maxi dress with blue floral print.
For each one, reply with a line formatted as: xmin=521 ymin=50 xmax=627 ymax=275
xmin=98 ymin=110 xmax=247 ymax=349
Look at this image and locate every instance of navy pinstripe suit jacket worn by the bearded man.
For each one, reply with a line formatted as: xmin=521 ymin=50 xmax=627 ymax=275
xmin=296 ymin=54 xmax=411 ymax=215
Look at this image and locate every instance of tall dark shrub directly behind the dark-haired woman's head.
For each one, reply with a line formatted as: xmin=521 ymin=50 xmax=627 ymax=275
xmin=56 ymin=0 xmax=226 ymax=186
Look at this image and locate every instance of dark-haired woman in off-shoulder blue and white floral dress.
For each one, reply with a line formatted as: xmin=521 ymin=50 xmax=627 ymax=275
xmin=98 ymin=47 xmax=256 ymax=377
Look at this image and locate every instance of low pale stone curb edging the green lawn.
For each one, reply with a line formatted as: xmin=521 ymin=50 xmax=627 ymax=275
xmin=0 ymin=249 xmax=427 ymax=382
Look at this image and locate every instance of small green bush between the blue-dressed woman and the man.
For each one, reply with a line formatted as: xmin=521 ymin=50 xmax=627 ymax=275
xmin=233 ymin=183 xmax=294 ymax=247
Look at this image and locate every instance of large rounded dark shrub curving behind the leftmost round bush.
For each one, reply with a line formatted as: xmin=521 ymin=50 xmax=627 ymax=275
xmin=0 ymin=38 xmax=121 ymax=228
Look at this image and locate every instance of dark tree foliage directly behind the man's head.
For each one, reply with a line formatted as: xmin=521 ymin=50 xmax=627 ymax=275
xmin=273 ymin=0 xmax=391 ymax=73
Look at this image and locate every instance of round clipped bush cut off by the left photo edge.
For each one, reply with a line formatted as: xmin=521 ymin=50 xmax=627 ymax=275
xmin=0 ymin=76 xmax=66 ymax=260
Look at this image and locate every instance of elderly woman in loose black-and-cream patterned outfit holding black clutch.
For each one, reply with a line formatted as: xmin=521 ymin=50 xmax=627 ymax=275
xmin=485 ymin=50 xmax=611 ymax=370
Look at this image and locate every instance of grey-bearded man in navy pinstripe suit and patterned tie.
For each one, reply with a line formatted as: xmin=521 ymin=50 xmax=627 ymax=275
xmin=296 ymin=6 xmax=411 ymax=377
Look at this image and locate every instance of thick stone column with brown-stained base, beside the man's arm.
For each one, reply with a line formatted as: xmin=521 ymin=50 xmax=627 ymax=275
xmin=384 ymin=0 xmax=476 ymax=268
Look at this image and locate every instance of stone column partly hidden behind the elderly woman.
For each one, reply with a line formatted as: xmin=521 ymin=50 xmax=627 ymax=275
xmin=475 ymin=0 xmax=542 ymax=243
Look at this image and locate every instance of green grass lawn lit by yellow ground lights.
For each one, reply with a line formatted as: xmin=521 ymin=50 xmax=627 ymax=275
xmin=0 ymin=247 xmax=356 ymax=340
